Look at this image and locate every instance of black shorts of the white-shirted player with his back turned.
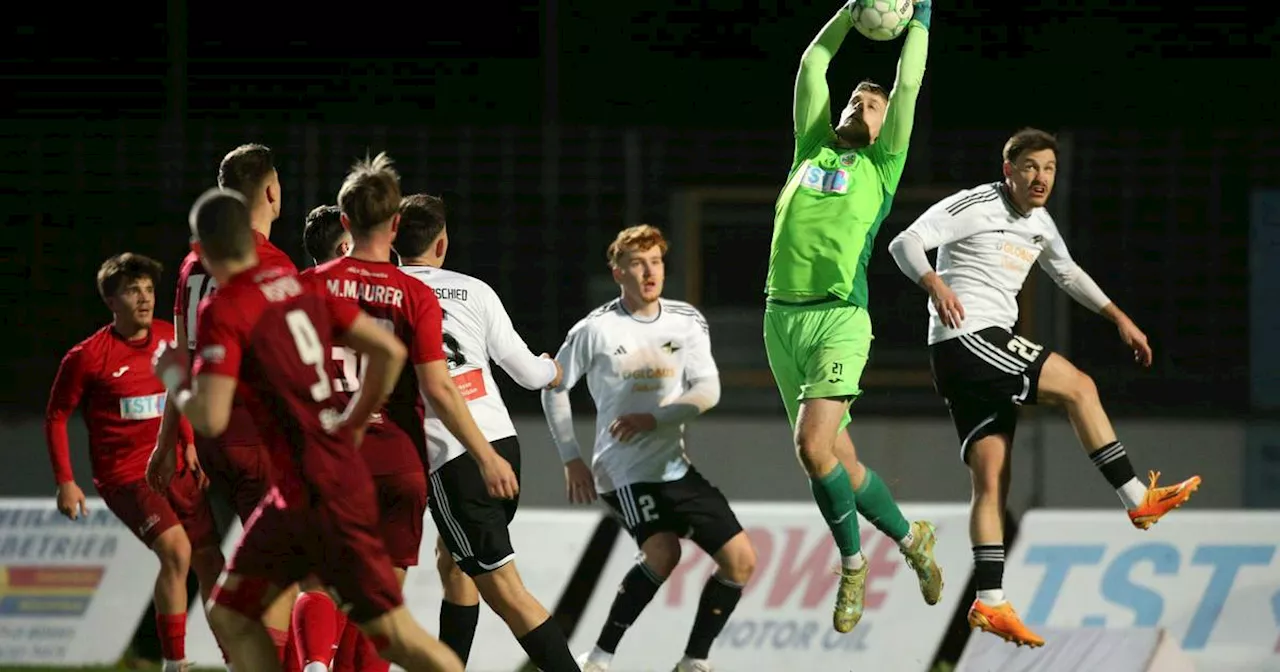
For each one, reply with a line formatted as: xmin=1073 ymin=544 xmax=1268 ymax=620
xmin=428 ymin=436 xmax=520 ymax=576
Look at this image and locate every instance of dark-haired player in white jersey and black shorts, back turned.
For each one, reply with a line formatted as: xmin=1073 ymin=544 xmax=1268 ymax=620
xmin=396 ymin=193 xmax=579 ymax=672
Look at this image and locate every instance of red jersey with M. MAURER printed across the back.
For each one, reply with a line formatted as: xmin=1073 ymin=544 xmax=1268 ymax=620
xmin=315 ymin=257 xmax=444 ymax=476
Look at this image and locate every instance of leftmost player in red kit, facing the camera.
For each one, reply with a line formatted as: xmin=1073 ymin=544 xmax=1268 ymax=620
xmin=45 ymin=252 xmax=221 ymax=672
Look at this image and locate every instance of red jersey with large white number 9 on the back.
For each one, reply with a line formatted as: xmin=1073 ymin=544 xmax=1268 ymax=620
xmin=192 ymin=265 xmax=360 ymax=506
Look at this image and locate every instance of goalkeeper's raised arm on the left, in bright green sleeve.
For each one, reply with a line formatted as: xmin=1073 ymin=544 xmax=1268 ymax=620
xmin=792 ymin=8 xmax=854 ymax=161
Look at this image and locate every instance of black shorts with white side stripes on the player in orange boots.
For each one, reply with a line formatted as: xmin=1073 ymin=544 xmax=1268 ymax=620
xmin=929 ymin=326 xmax=1050 ymax=462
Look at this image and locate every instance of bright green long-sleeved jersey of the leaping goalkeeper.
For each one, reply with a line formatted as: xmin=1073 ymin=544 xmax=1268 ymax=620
xmin=765 ymin=9 xmax=928 ymax=307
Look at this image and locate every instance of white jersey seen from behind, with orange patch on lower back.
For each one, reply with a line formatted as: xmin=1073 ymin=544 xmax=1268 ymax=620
xmin=401 ymin=266 xmax=556 ymax=474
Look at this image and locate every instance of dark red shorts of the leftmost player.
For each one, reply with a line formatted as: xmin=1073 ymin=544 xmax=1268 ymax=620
xmin=97 ymin=471 xmax=221 ymax=550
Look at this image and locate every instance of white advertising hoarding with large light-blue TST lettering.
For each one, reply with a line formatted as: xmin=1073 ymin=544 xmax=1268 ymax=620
xmin=1003 ymin=509 xmax=1280 ymax=672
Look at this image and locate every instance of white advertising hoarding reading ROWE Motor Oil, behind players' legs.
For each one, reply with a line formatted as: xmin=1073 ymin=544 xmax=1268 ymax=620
xmin=572 ymin=503 xmax=973 ymax=672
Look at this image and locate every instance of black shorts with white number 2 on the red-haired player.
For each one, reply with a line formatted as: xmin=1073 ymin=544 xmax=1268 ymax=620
xmin=600 ymin=466 xmax=742 ymax=556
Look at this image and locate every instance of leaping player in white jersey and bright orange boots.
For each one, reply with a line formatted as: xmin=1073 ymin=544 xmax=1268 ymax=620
xmin=890 ymin=128 xmax=1201 ymax=646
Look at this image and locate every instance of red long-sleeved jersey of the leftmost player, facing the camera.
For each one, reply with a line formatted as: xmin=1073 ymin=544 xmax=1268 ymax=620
xmin=45 ymin=320 xmax=193 ymax=486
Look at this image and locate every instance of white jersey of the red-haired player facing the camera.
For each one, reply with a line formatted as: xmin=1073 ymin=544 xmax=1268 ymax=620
xmin=556 ymin=298 xmax=719 ymax=493
